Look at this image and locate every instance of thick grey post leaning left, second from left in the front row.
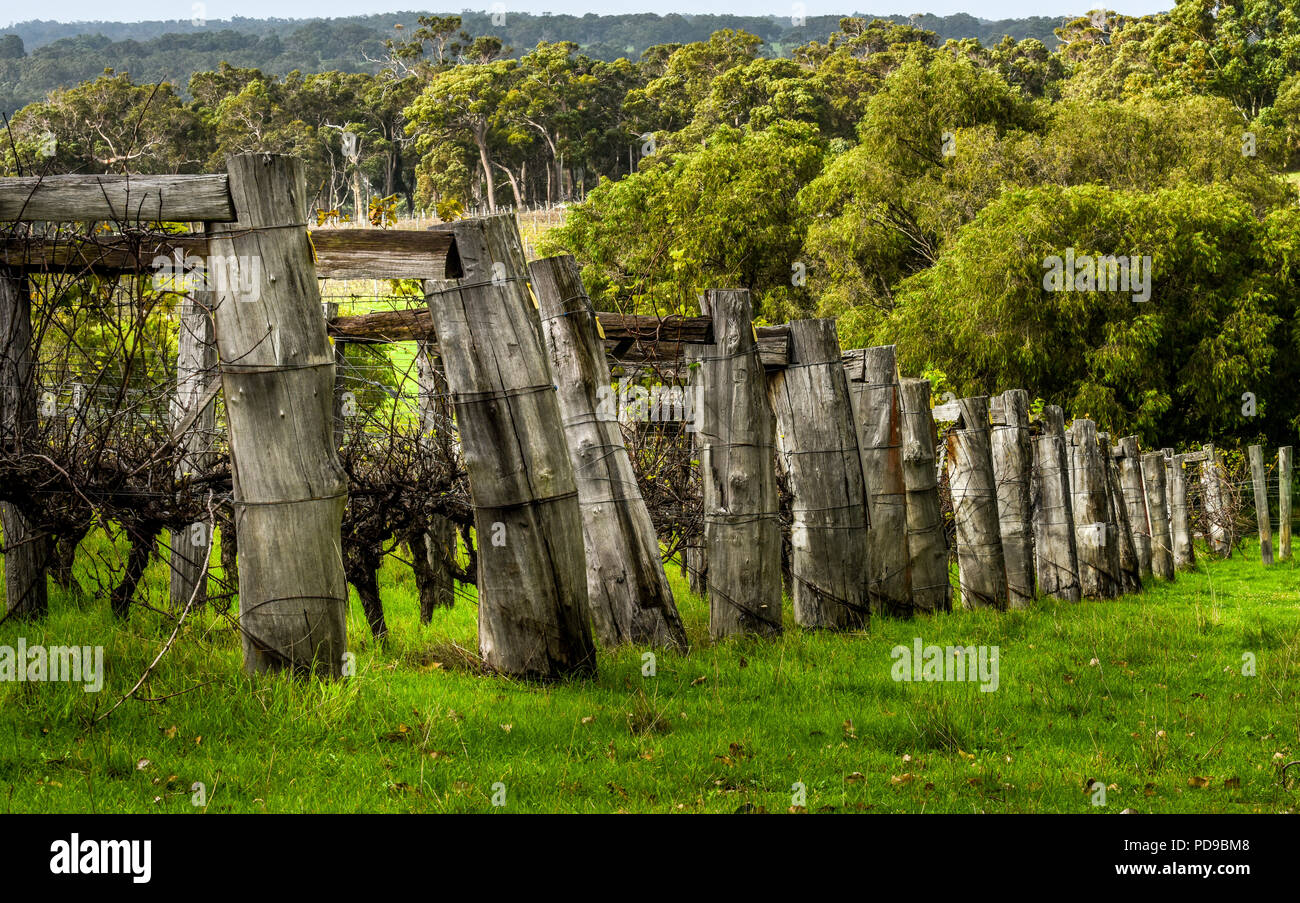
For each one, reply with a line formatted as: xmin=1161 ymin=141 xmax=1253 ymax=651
xmin=425 ymin=214 xmax=595 ymax=680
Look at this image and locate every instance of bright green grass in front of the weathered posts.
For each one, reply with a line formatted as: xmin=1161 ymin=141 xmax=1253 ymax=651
xmin=0 ymin=539 xmax=1300 ymax=813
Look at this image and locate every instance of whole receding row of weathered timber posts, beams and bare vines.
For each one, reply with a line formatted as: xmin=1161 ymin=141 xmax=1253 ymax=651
xmin=0 ymin=155 xmax=1291 ymax=678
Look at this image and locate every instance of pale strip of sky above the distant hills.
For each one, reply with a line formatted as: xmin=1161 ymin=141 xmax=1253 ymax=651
xmin=4 ymin=0 xmax=1173 ymax=25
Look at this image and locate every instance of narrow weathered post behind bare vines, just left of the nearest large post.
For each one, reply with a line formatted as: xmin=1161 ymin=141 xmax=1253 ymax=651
xmin=169 ymin=271 xmax=217 ymax=611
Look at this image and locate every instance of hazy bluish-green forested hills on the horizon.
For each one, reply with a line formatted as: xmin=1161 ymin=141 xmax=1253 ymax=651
xmin=0 ymin=11 xmax=1061 ymax=114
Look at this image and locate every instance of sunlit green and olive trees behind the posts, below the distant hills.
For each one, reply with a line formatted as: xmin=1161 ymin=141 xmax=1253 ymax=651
xmin=4 ymin=0 xmax=1300 ymax=444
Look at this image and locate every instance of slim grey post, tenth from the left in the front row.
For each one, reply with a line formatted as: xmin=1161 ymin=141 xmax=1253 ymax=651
xmin=1034 ymin=404 xmax=1080 ymax=602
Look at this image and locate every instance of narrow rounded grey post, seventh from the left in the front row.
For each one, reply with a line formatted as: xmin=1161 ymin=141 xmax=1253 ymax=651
xmin=898 ymin=379 xmax=953 ymax=612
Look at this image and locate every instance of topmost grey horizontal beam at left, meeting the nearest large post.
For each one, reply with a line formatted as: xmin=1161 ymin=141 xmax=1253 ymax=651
xmin=0 ymin=175 xmax=235 ymax=223
